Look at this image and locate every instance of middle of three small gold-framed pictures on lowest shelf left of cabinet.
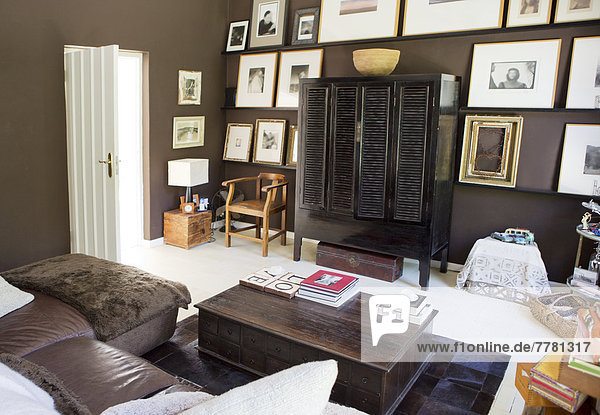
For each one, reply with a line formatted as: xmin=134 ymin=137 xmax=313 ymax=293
xmin=253 ymin=119 xmax=286 ymax=165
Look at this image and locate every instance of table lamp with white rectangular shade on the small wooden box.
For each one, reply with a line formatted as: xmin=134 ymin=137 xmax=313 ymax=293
xmin=168 ymin=159 xmax=208 ymax=213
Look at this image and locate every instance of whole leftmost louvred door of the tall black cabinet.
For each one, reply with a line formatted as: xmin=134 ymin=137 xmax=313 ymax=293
xmin=298 ymin=84 xmax=329 ymax=210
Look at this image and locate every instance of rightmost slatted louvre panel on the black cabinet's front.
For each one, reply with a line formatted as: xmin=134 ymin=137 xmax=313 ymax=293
xmin=394 ymin=86 xmax=429 ymax=222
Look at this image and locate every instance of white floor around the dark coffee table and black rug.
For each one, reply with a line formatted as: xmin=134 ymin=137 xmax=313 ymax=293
xmin=122 ymin=231 xmax=552 ymax=414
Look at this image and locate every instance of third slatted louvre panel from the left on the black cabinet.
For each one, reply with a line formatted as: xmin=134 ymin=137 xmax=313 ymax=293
xmin=358 ymin=87 xmax=391 ymax=219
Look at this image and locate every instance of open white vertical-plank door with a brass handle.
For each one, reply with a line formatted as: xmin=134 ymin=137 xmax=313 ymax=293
xmin=65 ymin=45 xmax=120 ymax=261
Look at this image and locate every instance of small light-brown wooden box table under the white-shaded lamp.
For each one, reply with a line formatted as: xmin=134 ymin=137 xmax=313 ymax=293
xmin=164 ymin=209 xmax=212 ymax=249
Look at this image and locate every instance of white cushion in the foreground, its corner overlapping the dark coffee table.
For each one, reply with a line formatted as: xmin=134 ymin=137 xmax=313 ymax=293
xmin=183 ymin=360 xmax=337 ymax=415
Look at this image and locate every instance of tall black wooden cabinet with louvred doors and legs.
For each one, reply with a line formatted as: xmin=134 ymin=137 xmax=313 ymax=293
xmin=294 ymin=74 xmax=460 ymax=287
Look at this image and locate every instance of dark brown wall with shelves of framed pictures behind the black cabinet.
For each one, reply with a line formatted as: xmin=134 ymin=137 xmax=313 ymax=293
xmin=223 ymin=0 xmax=600 ymax=281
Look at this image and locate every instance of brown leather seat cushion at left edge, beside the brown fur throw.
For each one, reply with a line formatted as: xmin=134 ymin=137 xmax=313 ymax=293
xmin=0 ymin=290 xmax=94 ymax=356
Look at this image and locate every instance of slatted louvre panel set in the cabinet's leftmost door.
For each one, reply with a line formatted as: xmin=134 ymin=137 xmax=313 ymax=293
xmin=302 ymin=87 xmax=328 ymax=209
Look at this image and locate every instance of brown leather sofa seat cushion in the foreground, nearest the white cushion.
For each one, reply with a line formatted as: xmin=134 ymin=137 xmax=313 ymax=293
xmin=26 ymin=337 xmax=177 ymax=414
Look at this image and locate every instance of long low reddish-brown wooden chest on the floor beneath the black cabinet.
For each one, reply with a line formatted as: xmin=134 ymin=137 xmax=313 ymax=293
xmin=317 ymin=242 xmax=404 ymax=282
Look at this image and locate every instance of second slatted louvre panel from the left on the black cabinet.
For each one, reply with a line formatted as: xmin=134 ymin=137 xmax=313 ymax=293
xmin=329 ymin=87 xmax=357 ymax=215
